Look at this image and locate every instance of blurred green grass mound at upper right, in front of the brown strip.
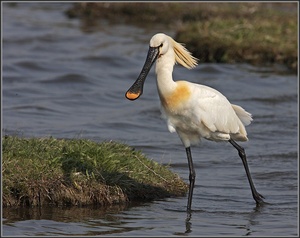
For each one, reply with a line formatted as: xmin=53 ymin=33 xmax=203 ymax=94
xmin=176 ymin=4 xmax=298 ymax=70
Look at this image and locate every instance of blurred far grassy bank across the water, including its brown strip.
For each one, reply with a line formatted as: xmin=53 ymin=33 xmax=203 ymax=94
xmin=66 ymin=2 xmax=298 ymax=73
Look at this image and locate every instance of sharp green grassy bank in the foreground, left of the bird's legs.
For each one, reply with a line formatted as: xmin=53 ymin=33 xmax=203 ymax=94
xmin=2 ymin=136 xmax=187 ymax=207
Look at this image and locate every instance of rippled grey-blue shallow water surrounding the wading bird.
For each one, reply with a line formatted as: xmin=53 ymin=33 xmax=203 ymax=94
xmin=2 ymin=3 xmax=298 ymax=236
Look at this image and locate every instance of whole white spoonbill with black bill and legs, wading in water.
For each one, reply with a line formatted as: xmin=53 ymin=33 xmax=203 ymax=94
xmin=125 ymin=33 xmax=264 ymax=214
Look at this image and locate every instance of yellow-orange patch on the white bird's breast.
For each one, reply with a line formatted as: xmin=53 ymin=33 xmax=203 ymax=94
xmin=161 ymin=81 xmax=191 ymax=111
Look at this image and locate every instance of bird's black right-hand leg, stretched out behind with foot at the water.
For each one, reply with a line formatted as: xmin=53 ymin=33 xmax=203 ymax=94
xmin=228 ymin=139 xmax=264 ymax=205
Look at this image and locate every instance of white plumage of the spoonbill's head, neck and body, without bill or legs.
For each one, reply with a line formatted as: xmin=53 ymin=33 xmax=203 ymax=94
xmin=150 ymin=31 xmax=252 ymax=147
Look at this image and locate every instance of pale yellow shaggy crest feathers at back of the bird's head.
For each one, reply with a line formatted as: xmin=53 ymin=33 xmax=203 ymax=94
xmin=170 ymin=37 xmax=198 ymax=69
